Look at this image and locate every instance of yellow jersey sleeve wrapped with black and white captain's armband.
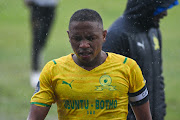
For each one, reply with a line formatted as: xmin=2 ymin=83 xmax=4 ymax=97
xmin=128 ymin=61 xmax=148 ymax=106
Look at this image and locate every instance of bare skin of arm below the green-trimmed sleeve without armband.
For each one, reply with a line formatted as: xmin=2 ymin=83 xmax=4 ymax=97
xmin=27 ymin=105 xmax=50 ymax=120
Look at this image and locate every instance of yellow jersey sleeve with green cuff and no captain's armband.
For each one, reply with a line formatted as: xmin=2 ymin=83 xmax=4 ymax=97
xmin=31 ymin=61 xmax=55 ymax=107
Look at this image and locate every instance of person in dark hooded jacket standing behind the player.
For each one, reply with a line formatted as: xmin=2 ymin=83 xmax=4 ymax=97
xmin=103 ymin=0 xmax=178 ymax=120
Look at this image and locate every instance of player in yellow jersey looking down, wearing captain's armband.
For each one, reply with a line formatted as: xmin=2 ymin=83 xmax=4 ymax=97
xmin=28 ymin=9 xmax=152 ymax=120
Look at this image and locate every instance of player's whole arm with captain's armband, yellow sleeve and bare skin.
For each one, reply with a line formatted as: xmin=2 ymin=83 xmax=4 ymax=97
xmin=128 ymin=61 xmax=152 ymax=120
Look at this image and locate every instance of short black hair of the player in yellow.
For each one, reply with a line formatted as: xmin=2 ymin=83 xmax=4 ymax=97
xmin=69 ymin=9 xmax=103 ymax=27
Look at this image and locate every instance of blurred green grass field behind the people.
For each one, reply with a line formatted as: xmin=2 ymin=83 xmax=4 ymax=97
xmin=0 ymin=0 xmax=180 ymax=120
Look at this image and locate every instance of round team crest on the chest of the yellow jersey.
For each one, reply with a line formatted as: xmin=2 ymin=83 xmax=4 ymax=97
xmin=96 ymin=75 xmax=116 ymax=91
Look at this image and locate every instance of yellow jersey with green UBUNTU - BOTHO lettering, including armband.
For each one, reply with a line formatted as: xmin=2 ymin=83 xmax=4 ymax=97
xmin=31 ymin=53 xmax=148 ymax=120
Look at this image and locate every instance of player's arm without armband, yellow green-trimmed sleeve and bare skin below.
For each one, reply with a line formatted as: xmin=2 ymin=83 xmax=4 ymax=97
xmin=28 ymin=61 xmax=55 ymax=120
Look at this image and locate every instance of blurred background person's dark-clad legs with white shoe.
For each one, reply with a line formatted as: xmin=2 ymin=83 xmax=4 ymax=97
xmin=25 ymin=0 xmax=58 ymax=87
